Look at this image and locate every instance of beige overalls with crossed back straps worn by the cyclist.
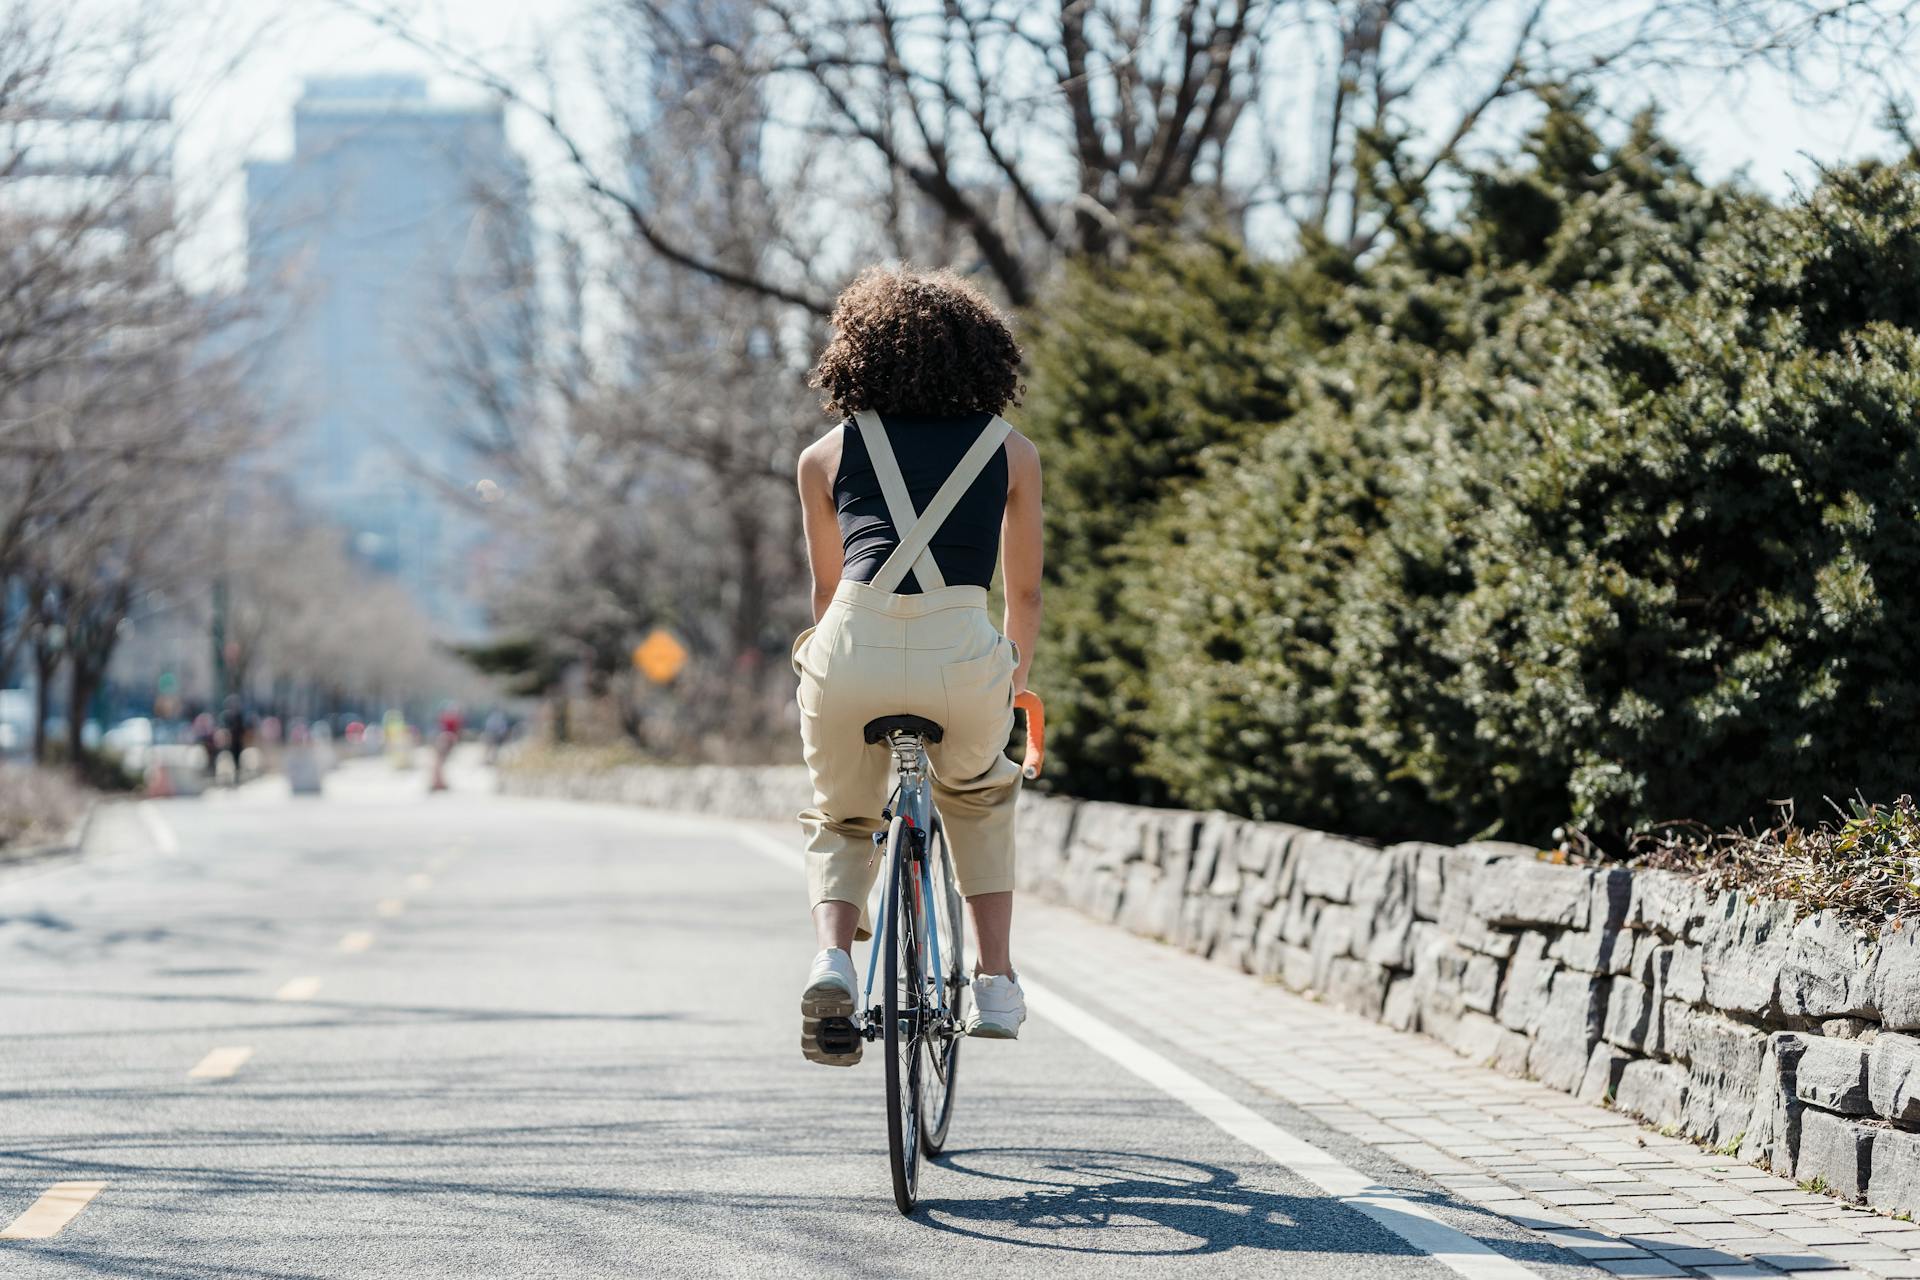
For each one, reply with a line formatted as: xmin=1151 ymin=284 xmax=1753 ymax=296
xmin=793 ymin=413 xmax=1020 ymax=938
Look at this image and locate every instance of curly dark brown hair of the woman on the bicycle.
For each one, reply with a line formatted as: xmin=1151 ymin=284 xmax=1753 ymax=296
xmin=806 ymin=267 xmax=1025 ymax=418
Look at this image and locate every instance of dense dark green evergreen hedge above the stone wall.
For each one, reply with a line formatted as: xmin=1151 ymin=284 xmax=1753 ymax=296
xmin=1029 ymin=104 xmax=1920 ymax=844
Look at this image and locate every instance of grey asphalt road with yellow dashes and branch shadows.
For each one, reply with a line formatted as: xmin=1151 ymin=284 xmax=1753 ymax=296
xmin=0 ymin=766 xmax=1596 ymax=1280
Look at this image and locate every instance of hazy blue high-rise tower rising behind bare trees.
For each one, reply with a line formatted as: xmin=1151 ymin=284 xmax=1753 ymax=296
xmin=248 ymin=75 xmax=530 ymax=639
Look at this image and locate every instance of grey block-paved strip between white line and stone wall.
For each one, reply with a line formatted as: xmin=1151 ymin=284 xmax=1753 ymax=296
xmin=1014 ymin=898 xmax=1920 ymax=1280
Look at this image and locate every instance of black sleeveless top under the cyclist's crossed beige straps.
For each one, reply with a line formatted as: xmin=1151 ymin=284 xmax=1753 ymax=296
xmin=833 ymin=413 xmax=1006 ymax=595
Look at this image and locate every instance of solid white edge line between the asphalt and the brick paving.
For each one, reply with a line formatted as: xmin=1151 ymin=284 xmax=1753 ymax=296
xmin=708 ymin=827 xmax=1540 ymax=1280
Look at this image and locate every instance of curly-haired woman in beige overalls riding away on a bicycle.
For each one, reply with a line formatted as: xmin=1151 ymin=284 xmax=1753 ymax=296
xmin=793 ymin=269 xmax=1041 ymax=1067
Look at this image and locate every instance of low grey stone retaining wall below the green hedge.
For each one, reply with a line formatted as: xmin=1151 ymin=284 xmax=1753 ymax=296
xmin=503 ymin=768 xmax=1920 ymax=1213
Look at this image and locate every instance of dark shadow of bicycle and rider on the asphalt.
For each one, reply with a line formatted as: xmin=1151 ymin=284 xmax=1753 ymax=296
xmin=920 ymin=1148 xmax=1459 ymax=1257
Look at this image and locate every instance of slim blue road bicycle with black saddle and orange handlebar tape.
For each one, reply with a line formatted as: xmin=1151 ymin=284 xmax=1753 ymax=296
xmin=854 ymin=693 xmax=1046 ymax=1213
